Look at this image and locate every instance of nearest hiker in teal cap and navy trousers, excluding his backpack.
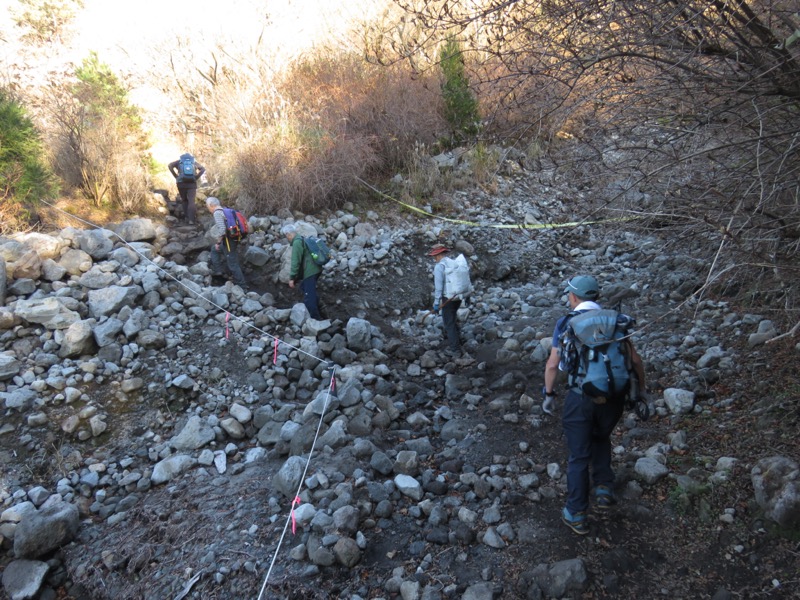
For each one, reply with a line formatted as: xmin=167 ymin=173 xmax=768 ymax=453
xmin=542 ymin=275 xmax=645 ymax=535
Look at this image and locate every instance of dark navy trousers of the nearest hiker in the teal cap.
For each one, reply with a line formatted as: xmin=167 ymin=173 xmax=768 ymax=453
xmin=561 ymin=390 xmax=624 ymax=515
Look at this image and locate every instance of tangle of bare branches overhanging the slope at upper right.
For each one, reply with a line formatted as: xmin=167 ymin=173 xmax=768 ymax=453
xmin=382 ymin=0 xmax=800 ymax=308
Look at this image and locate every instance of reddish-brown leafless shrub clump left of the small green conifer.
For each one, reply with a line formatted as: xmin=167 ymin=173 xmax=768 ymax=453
xmin=223 ymin=50 xmax=444 ymax=213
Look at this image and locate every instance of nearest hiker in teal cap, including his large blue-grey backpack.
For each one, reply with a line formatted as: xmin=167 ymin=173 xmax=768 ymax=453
xmin=542 ymin=275 xmax=645 ymax=535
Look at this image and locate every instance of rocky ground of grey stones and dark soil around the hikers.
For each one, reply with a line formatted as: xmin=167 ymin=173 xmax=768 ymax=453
xmin=0 ymin=159 xmax=800 ymax=600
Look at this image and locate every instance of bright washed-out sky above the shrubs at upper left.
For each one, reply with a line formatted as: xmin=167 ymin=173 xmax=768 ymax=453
xmin=0 ymin=0 xmax=390 ymax=161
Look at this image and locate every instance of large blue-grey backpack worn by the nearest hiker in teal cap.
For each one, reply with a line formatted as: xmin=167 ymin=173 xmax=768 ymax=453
xmin=559 ymin=310 xmax=636 ymax=401
